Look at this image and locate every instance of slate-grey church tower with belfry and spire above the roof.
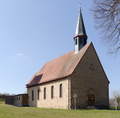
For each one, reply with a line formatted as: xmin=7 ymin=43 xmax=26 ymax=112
xmin=74 ymin=8 xmax=87 ymax=54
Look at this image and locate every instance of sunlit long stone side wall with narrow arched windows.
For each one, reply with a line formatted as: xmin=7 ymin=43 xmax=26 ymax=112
xmin=27 ymin=78 xmax=69 ymax=109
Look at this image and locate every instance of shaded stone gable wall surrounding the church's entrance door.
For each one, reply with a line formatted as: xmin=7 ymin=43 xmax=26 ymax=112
xmin=70 ymin=44 xmax=109 ymax=108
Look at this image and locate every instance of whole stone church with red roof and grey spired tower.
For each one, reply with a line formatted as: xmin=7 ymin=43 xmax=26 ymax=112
xmin=26 ymin=8 xmax=110 ymax=109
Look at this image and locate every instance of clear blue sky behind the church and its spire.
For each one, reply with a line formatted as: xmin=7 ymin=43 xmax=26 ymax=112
xmin=0 ymin=0 xmax=120 ymax=97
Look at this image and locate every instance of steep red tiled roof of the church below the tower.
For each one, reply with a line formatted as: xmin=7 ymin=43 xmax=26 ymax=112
xmin=27 ymin=42 xmax=92 ymax=87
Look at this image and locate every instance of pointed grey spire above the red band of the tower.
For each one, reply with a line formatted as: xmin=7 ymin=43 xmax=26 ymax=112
xmin=74 ymin=8 xmax=87 ymax=39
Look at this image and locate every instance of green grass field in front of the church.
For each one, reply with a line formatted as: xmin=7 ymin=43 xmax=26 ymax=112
xmin=0 ymin=102 xmax=120 ymax=118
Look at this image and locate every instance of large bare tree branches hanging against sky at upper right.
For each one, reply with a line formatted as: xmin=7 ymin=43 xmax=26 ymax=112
xmin=91 ymin=0 xmax=120 ymax=54
